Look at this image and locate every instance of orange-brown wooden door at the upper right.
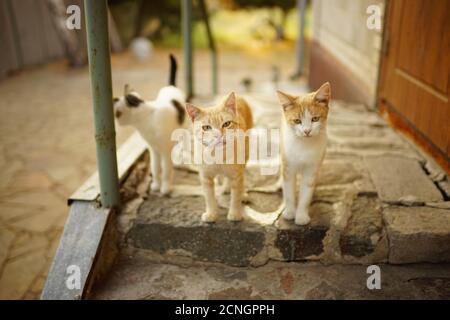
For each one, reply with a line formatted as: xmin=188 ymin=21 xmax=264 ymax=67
xmin=378 ymin=0 xmax=450 ymax=167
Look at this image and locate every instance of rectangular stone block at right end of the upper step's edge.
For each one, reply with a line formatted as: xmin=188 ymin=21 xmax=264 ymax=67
xmin=383 ymin=207 xmax=450 ymax=263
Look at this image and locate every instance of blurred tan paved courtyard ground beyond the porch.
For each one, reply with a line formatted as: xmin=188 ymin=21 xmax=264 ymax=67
xmin=0 ymin=49 xmax=300 ymax=299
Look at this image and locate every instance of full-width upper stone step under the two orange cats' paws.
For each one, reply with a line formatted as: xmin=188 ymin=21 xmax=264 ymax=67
xmin=126 ymin=163 xmax=450 ymax=266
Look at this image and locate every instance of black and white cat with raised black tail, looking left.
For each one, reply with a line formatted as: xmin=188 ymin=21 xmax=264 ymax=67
xmin=114 ymin=55 xmax=186 ymax=194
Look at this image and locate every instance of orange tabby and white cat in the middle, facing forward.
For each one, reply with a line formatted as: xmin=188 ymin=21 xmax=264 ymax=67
xmin=186 ymin=92 xmax=253 ymax=222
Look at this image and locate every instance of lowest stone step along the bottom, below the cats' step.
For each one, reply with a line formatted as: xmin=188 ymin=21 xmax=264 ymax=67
xmin=92 ymin=257 xmax=450 ymax=300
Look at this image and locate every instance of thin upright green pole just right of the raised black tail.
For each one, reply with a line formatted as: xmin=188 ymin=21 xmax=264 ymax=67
xmin=181 ymin=0 xmax=194 ymax=98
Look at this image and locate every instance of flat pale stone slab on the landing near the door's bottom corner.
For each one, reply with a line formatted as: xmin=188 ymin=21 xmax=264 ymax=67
xmin=365 ymin=156 xmax=443 ymax=203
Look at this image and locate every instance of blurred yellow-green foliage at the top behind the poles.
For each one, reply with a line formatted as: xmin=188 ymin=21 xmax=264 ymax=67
xmin=109 ymin=0 xmax=311 ymax=48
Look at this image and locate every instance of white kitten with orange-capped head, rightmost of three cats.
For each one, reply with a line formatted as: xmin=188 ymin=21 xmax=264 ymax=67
xmin=277 ymin=82 xmax=331 ymax=225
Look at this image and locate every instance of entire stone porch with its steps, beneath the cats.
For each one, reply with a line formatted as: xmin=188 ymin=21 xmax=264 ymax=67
xmin=90 ymin=95 xmax=450 ymax=299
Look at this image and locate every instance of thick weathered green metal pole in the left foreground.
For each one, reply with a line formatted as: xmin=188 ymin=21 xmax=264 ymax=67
xmin=84 ymin=0 xmax=120 ymax=207
